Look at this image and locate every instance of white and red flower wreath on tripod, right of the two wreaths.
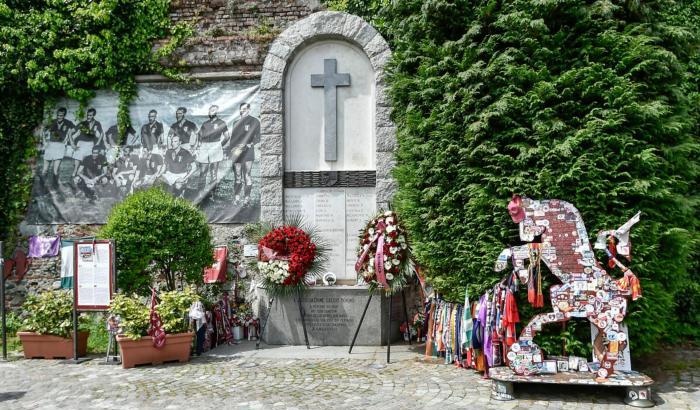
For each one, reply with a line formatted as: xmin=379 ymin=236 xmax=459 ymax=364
xmin=355 ymin=211 xmax=416 ymax=294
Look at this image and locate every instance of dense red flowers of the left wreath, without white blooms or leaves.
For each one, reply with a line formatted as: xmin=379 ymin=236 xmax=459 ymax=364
xmin=258 ymin=226 xmax=316 ymax=285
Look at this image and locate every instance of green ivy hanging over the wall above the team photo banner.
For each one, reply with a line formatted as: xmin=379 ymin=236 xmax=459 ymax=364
xmin=0 ymin=0 xmax=192 ymax=251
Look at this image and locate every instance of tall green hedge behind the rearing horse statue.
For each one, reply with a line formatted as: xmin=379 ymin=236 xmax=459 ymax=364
xmin=379 ymin=0 xmax=700 ymax=353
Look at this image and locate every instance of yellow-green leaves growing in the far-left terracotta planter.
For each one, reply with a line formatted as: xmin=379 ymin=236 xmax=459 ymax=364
xmin=20 ymin=290 xmax=87 ymax=337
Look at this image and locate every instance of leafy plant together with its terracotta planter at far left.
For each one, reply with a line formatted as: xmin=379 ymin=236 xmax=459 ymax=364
xmin=17 ymin=291 xmax=90 ymax=359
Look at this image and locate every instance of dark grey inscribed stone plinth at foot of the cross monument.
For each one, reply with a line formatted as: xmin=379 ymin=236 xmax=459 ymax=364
xmin=258 ymin=286 xmax=414 ymax=346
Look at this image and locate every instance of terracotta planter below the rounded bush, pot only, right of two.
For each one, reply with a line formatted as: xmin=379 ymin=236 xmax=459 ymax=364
xmin=117 ymin=332 xmax=194 ymax=369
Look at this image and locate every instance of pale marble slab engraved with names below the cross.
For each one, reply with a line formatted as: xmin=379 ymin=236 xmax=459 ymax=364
xmin=284 ymin=188 xmax=376 ymax=281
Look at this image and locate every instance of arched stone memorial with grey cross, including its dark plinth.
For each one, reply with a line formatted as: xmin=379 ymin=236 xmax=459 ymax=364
xmin=258 ymin=11 xmax=401 ymax=345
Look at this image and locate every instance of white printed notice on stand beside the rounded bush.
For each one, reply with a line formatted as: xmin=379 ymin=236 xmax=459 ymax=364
xmin=75 ymin=243 xmax=111 ymax=306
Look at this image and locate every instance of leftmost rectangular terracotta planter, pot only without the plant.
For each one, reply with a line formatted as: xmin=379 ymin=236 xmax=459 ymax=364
xmin=17 ymin=332 xmax=90 ymax=359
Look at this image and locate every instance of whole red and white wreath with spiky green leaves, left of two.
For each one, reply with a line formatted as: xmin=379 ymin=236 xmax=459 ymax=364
xmin=248 ymin=218 xmax=327 ymax=297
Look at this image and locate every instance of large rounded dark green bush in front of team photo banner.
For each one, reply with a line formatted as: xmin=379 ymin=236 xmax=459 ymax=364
xmin=100 ymin=187 xmax=214 ymax=295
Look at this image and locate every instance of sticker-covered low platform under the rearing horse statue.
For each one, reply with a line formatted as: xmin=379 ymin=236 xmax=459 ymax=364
xmin=489 ymin=367 xmax=655 ymax=407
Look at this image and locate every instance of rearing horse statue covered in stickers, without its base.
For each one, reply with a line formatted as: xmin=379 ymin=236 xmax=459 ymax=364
xmin=496 ymin=196 xmax=641 ymax=379
